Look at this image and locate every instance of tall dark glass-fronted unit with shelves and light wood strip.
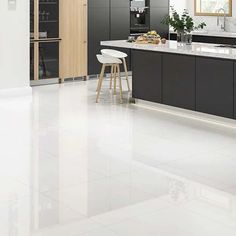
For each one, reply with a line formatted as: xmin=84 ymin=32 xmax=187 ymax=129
xmin=30 ymin=0 xmax=60 ymax=85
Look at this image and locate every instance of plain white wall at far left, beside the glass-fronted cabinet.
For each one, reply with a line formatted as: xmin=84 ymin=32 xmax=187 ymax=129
xmin=0 ymin=0 xmax=29 ymax=90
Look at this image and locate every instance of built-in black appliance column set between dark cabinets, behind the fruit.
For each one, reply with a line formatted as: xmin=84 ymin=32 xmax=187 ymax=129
xmin=130 ymin=0 xmax=150 ymax=35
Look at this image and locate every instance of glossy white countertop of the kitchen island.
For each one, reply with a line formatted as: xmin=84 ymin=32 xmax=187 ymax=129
xmin=101 ymin=40 xmax=236 ymax=60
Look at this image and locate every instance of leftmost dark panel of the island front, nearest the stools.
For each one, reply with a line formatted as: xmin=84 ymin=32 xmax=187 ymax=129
xmin=132 ymin=50 xmax=162 ymax=103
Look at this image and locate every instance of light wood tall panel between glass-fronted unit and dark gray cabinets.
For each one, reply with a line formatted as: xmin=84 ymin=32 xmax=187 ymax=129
xmin=60 ymin=0 xmax=87 ymax=80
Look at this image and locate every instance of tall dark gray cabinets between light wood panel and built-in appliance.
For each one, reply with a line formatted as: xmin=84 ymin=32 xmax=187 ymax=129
xmin=88 ymin=0 xmax=130 ymax=75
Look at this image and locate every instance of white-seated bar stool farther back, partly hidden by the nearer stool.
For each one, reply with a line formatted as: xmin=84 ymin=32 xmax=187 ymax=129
xmin=101 ymin=49 xmax=130 ymax=91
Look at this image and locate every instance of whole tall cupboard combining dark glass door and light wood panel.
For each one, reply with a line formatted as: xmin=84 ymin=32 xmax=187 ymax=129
xmin=30 ymin=0 xmax=87 ymax=85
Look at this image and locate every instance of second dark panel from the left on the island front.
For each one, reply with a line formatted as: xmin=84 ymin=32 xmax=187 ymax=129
xmin=163 ymin=54 xmax=195 ymax=110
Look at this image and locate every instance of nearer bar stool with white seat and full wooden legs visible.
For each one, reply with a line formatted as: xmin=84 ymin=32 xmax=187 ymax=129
xmin=96 ymin=54 xmax=123 ymax=103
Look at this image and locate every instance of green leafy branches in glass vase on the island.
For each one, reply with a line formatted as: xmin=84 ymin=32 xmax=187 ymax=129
xmin=162 ymin=6 xmax=206 ymax=44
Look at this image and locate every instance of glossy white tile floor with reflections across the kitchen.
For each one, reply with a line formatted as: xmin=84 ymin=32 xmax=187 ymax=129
xmin=0 ymin=81 xmax=236 ymax=236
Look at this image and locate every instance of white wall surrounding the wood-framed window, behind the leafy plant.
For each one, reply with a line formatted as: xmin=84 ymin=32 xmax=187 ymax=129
xmin=170 ymin=0 xmax=236 ymax=32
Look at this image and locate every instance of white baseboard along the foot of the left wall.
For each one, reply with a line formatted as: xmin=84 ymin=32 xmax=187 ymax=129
xmin=0 ymin=87 xmax=32 ymax=99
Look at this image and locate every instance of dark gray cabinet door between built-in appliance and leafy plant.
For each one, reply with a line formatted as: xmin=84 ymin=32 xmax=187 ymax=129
xmin=150 ymin=7 xmax=169 ymax=38
